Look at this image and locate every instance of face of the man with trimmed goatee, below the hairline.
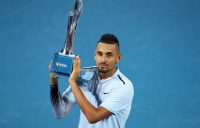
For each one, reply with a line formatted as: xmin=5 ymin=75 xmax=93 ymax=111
xmin=94 ymin=42 xmax=121 ymax=73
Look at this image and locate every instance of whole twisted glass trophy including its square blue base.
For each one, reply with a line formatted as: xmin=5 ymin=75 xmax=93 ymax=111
xmin=50 ymin=0 xmax=83 ymax=76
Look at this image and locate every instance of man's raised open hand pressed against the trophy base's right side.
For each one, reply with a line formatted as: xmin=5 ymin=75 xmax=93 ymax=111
xmin=69 ymin=56 xmax=81 ymax=84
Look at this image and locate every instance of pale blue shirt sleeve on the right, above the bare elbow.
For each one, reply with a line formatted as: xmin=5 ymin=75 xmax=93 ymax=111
xmin=100 ymin=85 xmax=133 ymax=114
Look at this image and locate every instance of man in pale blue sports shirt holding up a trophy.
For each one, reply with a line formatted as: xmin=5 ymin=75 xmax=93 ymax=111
xmin=50 ymin=34 xmax=134 ymax=128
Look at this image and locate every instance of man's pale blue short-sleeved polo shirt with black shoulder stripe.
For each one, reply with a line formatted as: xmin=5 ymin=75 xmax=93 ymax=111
xmin=63 ymin=68 xmax=134 ymax=128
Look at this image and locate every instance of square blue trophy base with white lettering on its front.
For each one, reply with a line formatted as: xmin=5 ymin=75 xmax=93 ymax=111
xmin=50 ymin=53 xmax=75 ymax=77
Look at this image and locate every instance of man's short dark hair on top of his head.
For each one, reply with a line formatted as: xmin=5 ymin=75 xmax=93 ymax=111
xmin=97 ymin=33 xmax=119 ymax=47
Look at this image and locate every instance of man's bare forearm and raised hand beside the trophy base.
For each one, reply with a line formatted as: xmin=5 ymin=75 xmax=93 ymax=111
xmin=69 ymin=57 xmax=112 ymax=123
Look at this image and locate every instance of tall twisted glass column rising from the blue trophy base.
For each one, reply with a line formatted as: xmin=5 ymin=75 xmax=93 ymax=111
xmin=61 ymin=0 xmax=83 ymax=55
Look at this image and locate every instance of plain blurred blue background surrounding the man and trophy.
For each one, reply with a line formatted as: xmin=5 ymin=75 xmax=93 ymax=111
xmin=0 ymin=0 xmax=200 ymax=128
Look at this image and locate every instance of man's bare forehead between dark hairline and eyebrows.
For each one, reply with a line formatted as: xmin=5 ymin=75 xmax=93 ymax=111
xmin=96 ymin=42 xmax=118 ymax=53
